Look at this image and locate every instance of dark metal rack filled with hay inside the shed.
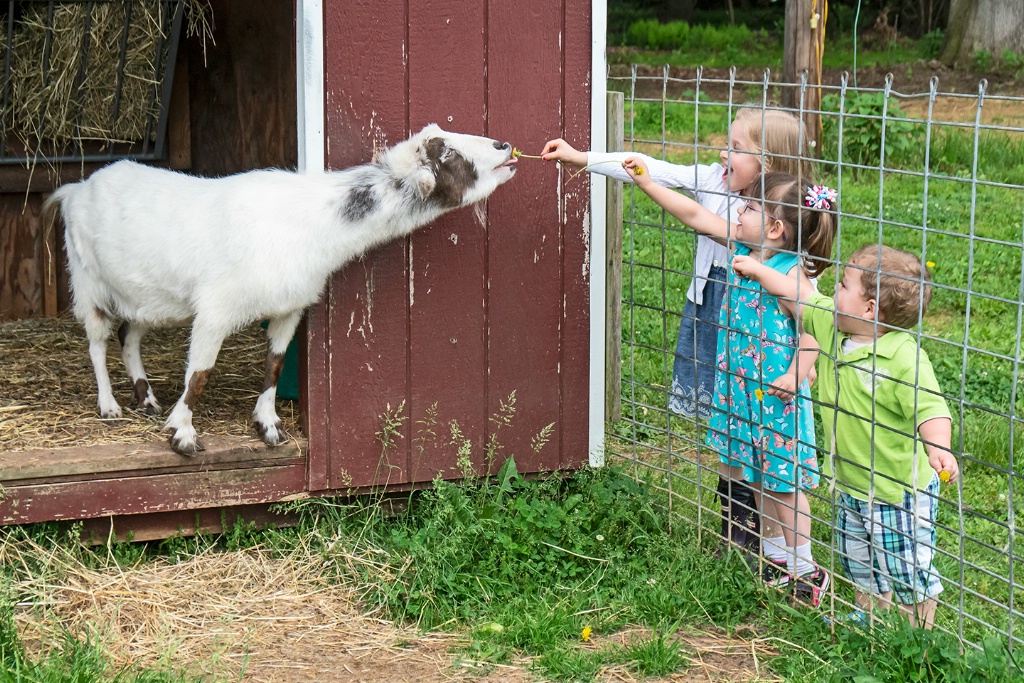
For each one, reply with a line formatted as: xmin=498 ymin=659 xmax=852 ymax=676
xmin=0 ymin=0 xmax=185 ymax=165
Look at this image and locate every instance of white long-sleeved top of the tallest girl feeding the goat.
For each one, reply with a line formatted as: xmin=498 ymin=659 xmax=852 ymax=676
xmin=587 ymin=152 xmax=742 ymax=305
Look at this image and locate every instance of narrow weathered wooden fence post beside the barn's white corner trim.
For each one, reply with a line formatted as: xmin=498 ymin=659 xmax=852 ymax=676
xmin=604 ymin=92 xmax=625 ymax=422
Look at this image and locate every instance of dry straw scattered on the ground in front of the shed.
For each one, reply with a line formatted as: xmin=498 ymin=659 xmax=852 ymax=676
xmin=9 ymin=546 xmax=777 ymax=683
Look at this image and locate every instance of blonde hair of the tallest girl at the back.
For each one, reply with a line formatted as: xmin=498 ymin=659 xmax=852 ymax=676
xmin=733 ymin=106 xmax=814 ymax=185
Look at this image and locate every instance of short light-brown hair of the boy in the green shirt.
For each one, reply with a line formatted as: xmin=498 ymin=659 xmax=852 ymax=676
xmin=847 ymin=245 xmax=932 ymax=330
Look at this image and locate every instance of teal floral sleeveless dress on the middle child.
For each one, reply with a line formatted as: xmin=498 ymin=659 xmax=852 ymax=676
xmin=708 ymin=245 xmax=820 ymax=493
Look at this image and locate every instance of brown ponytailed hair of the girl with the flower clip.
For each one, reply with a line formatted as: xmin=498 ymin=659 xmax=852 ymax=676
xmin=751 ymin=171 xmax=838 ymax=278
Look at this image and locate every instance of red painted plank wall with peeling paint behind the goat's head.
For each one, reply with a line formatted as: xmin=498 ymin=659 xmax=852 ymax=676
xmin=307 ymin=0 xmax=591 ymax=490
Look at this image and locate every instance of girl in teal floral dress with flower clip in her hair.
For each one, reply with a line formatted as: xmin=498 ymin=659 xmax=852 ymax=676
xmin=623 ymin=157 xmax=837 ymax=607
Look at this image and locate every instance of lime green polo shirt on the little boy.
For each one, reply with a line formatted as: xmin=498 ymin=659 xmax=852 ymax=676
xmin=803 ymin=293 xmax=949 ymax=504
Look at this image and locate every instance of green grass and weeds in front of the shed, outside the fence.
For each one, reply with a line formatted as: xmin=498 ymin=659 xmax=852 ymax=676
xmin=8 ymin=446 xmax=1024 ymax=683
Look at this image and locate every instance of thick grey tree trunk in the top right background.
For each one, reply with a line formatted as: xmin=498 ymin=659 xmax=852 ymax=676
xmin=940 ymin=0 xmax=1024 ymax=67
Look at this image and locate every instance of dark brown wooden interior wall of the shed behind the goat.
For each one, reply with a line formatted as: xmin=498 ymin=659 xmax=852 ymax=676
xmin=0 ymin=0 xmax=298 ymax=323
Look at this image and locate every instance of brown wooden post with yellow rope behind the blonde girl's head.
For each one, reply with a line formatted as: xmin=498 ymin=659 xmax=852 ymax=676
xmin=782 ymin=0 xmax=827 ymax=156
